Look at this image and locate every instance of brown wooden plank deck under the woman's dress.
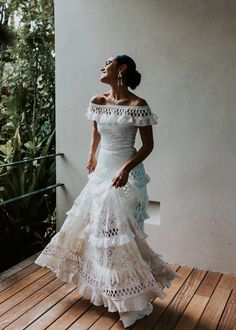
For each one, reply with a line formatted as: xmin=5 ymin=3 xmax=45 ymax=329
xmin=0 ymin=254 xmax=236 ymax=330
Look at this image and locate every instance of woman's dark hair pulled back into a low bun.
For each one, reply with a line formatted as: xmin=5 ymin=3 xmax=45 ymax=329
xmin=114 ymin=55 xmax=141 ymax=89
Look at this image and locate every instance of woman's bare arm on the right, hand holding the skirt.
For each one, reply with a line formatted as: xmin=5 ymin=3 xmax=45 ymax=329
xmin=112 ymin=125 xmax=154 ymax=188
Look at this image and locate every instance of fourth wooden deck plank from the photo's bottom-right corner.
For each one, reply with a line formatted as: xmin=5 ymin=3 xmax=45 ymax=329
xmin=153 ymin=269 xmax=207 ymax=330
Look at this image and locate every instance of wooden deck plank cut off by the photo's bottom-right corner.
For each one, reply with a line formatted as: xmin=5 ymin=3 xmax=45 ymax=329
xmin=217 ymin=289 xmax=236 ymax=330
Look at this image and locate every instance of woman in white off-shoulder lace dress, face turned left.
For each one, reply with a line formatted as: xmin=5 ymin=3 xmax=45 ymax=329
xmin=35 ymin=55 xmax=180 ymax=327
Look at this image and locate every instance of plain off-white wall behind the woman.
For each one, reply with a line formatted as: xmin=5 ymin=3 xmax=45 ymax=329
xmin=55 ymin=0 xmax=236 ymax=274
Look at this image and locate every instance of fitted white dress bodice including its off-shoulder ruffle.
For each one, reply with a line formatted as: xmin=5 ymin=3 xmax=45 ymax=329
xmin=86 ymin=103 xmax=157 ymax=172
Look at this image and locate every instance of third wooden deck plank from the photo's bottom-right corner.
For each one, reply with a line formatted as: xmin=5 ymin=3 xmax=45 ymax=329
xmin=175 ymin=272 xmax=221 ymax=330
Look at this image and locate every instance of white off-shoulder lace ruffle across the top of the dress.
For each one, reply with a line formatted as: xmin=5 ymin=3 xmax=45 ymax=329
xmin=85 ymin=103 xmax=158 ymax=126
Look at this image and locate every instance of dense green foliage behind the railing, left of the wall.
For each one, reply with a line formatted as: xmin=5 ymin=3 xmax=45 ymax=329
xmin=0 ymin=0 xmax=56 ymax=271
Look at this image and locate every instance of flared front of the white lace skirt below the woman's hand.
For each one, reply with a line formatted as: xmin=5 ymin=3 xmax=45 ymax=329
xmin=35 ymin=169 xmax=180 ymax=312
